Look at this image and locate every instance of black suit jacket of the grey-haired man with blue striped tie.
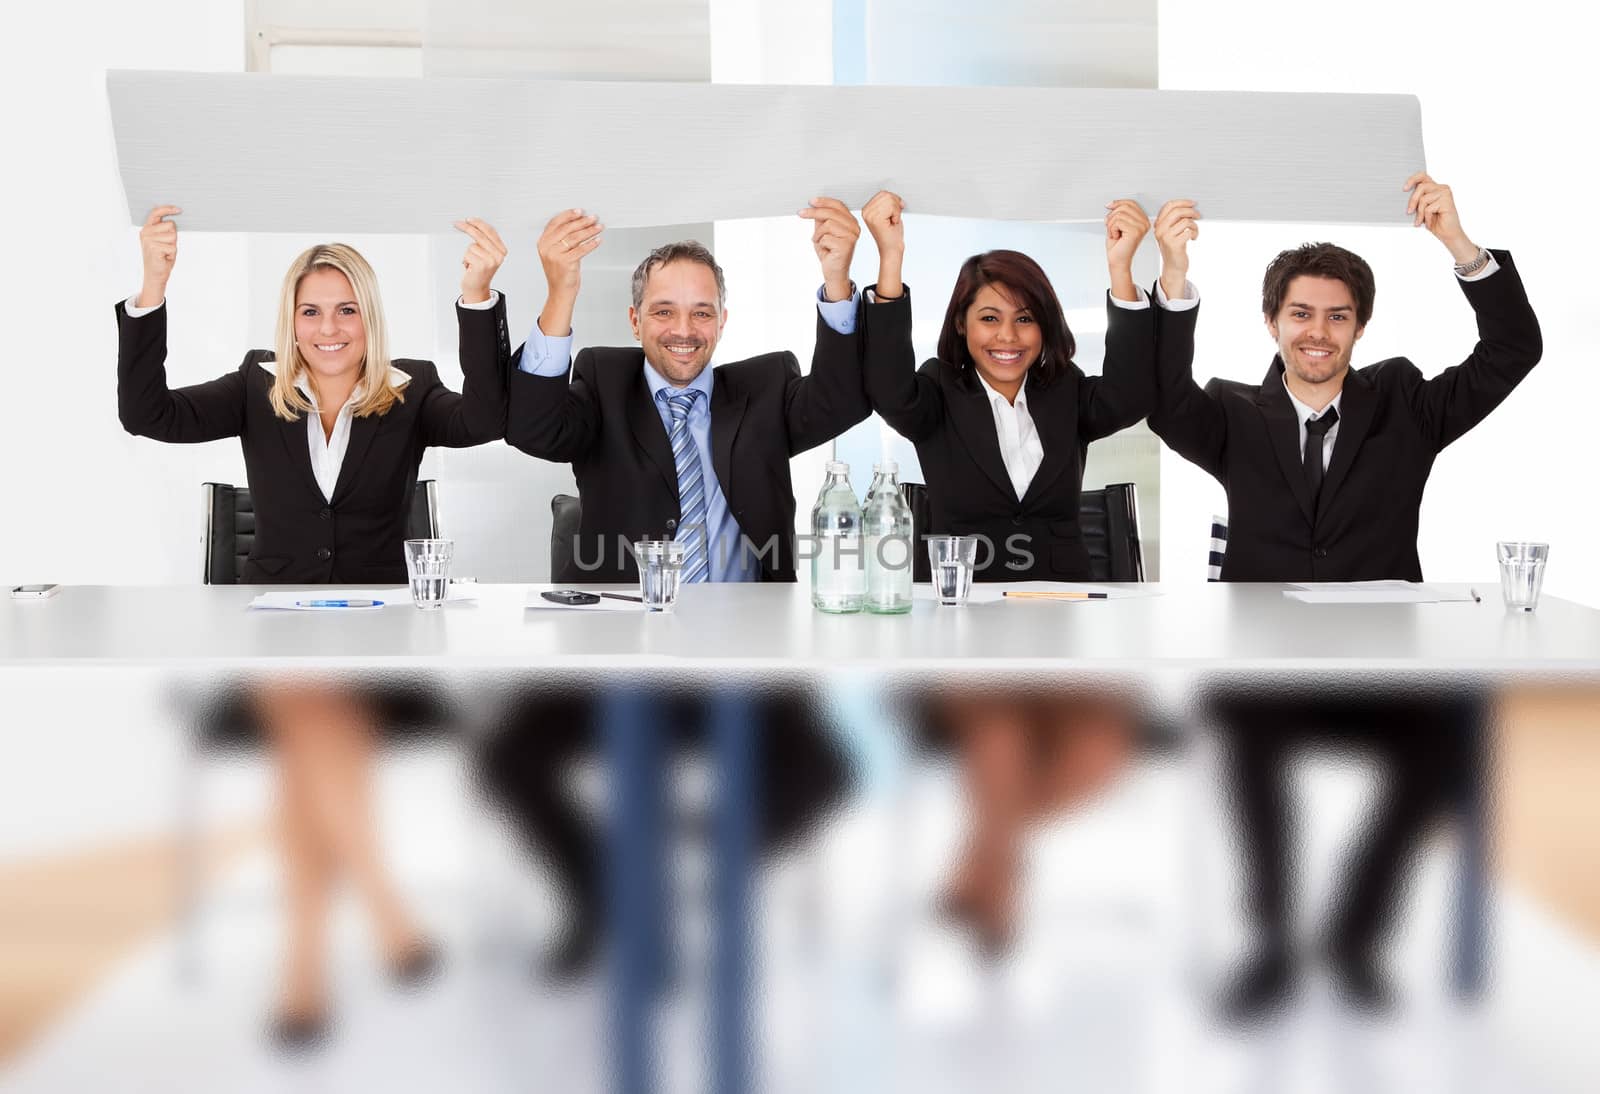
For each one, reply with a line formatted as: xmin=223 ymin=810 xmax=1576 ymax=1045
xmin=506 ymin=317 xmax=869 ymax=582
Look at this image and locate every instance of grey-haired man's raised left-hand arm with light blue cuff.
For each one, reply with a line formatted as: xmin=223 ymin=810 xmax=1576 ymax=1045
xmin=506 ymin=210 xmax=605 ymax=462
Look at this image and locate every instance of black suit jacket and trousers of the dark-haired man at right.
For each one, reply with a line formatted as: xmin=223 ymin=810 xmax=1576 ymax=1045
xmin=1150 ymin=251 xmax=1542 ymax=960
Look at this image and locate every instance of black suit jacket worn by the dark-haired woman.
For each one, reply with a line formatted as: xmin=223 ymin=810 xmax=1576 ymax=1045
xmin=862 ymin=288 xmax=1155 ymax=581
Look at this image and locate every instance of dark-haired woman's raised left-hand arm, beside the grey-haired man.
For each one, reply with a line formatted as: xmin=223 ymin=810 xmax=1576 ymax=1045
xmin=861 ymin=190 xmax=944 ymax=443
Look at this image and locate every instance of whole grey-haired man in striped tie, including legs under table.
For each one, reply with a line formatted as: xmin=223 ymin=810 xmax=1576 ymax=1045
xmin=492 ymin=198 xmax=869 ymax=982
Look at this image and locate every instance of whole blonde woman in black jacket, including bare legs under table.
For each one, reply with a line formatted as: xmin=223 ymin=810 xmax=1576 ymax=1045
xmin=117 ymin=205 xmax=510 ymax=1048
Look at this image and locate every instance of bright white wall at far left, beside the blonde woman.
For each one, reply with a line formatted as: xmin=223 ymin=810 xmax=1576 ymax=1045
xmin=0 ymin=0 xmax=248 ymax=582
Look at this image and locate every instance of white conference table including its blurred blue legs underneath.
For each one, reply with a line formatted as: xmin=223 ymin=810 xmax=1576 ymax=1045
xmin=0 ymin=582 xmax=1600 ymax=1094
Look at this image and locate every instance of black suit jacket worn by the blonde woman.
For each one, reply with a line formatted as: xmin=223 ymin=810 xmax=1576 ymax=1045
xmin=117 ymin=296 xmax=510 ymax=584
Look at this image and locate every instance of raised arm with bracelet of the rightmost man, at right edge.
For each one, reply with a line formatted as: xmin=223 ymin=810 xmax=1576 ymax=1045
xmin=1405 ymin=173 xmax=1544 ymax=448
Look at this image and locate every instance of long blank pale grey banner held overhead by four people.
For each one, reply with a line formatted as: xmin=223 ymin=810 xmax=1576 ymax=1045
xmin=106 ymin=72 xmax=1424 ymax=232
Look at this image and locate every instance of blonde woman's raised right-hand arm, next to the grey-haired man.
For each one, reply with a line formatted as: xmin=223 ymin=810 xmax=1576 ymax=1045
xmin=419 ymin=218 xmax=510 ymax=448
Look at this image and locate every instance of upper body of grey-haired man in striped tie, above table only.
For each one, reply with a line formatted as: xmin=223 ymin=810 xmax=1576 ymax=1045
xmin=506 ymin=198 xmax=870 ymax=582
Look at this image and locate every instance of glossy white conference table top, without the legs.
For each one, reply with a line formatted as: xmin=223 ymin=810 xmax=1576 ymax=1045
xmin=0 ymin=582 xmax=1600 ymax=680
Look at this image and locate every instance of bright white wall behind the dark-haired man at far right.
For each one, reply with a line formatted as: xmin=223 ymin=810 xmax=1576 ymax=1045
xmin=1160 ymin=0 xmax=1600 ymax=605
